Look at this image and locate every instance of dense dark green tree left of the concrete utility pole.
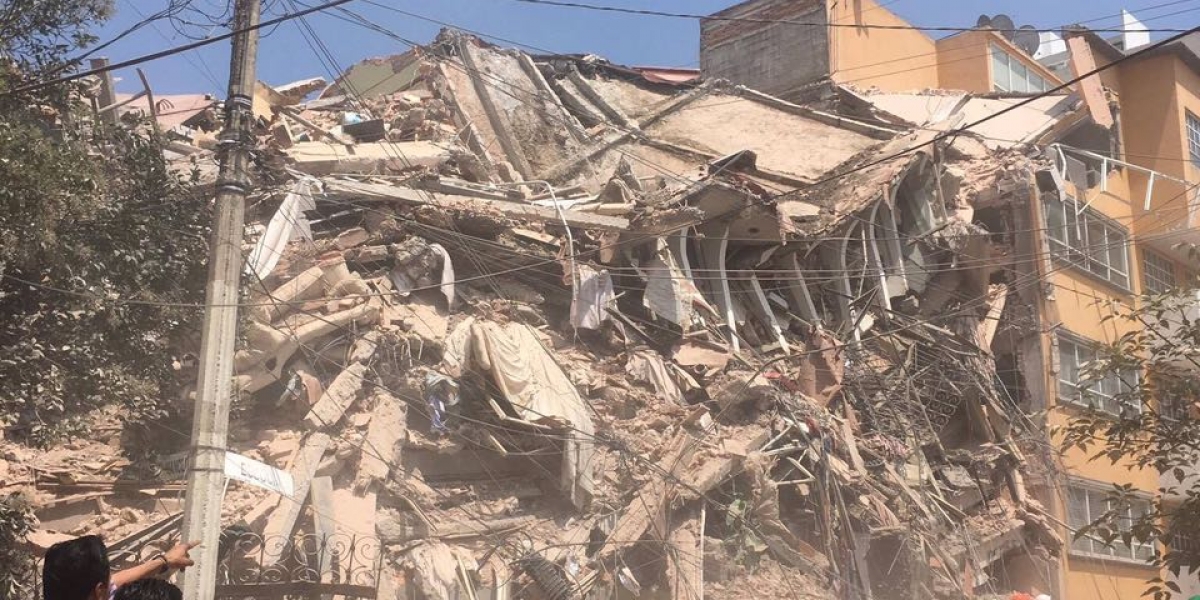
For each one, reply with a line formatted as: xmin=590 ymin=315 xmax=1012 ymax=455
xmin=0 ymin=0 xmax=209 ymax=443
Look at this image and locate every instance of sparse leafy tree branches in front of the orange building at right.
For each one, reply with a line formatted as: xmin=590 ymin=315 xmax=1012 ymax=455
xmin=1060 ymin=286 xmax=1200 ymax=600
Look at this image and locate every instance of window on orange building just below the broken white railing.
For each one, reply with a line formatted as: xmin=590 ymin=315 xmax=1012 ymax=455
xmin=1042 ymin=194 xmax=1129 ymax=289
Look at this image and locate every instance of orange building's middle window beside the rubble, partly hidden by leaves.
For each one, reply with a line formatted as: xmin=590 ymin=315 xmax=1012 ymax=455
xmin=1058 ymin=334 xmax=1141 ymax=415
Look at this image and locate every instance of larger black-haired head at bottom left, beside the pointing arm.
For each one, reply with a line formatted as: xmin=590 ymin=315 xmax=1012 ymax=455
xmin=42 ymin=535 xmax=109 ymax=600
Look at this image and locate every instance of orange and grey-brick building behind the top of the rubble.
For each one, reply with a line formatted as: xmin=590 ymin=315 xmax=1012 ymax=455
xmin=700 ymin=0 xmax=1061 ymax=100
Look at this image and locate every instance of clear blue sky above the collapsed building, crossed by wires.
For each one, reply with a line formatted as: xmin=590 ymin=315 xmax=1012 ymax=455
xmin=97 ymin=0 xmax=1200 ymax=96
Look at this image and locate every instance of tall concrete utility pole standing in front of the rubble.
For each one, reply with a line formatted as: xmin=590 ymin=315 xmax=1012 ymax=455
xmin=182 ymin=0 xmax=262 ymax=600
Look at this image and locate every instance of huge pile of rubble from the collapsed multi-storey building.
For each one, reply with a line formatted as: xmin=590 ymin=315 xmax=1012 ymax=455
xmin=11 ymin=31 xmax=1080 ymax=599
